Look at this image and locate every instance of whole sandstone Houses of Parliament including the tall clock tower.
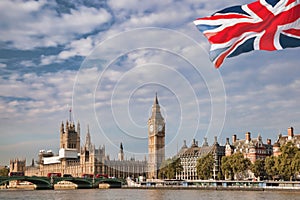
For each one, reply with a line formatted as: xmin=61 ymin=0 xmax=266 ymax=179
xmin=10 ymin=95 xmax=165 ymax=179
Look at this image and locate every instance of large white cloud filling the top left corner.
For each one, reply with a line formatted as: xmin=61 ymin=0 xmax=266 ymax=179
xmin=0 ymin=0 xmax=112 ymax=49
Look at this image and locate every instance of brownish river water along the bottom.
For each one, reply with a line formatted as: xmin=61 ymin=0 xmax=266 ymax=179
xmin=0 ymin=189 xmax=300 ymax=200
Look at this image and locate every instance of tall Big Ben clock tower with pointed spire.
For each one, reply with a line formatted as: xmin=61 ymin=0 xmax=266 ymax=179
xmin=148 ymin=94 xmax=165 ymax=179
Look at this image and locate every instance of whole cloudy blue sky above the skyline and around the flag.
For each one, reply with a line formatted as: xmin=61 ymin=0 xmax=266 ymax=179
xmin=0 ymin=0 xmax=300 ymax=165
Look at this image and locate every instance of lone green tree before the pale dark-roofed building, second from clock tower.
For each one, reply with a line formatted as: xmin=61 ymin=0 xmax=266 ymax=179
xmin=196 ymin=153 xmax=214 ymax=180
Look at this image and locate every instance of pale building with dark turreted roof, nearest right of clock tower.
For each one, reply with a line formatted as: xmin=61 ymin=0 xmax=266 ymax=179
xmin=176 ymin=137 xmax=225 ymax=180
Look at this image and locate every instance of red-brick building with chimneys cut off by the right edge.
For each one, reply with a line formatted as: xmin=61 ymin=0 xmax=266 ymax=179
xmin=273 ymin=127 xmax=300 ymax=156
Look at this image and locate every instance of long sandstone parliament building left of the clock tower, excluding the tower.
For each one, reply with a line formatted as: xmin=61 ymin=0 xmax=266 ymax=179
xmin=20 ymin=121 xmax=147 ymax=178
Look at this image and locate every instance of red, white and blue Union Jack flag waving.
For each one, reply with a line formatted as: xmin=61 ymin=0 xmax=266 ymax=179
xmin=194 ymin=0 xmax=300 ymax=68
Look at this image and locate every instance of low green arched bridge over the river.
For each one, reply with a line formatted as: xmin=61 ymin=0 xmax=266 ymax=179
xmin=0 ymin=176 xmax=122 ymax=189
